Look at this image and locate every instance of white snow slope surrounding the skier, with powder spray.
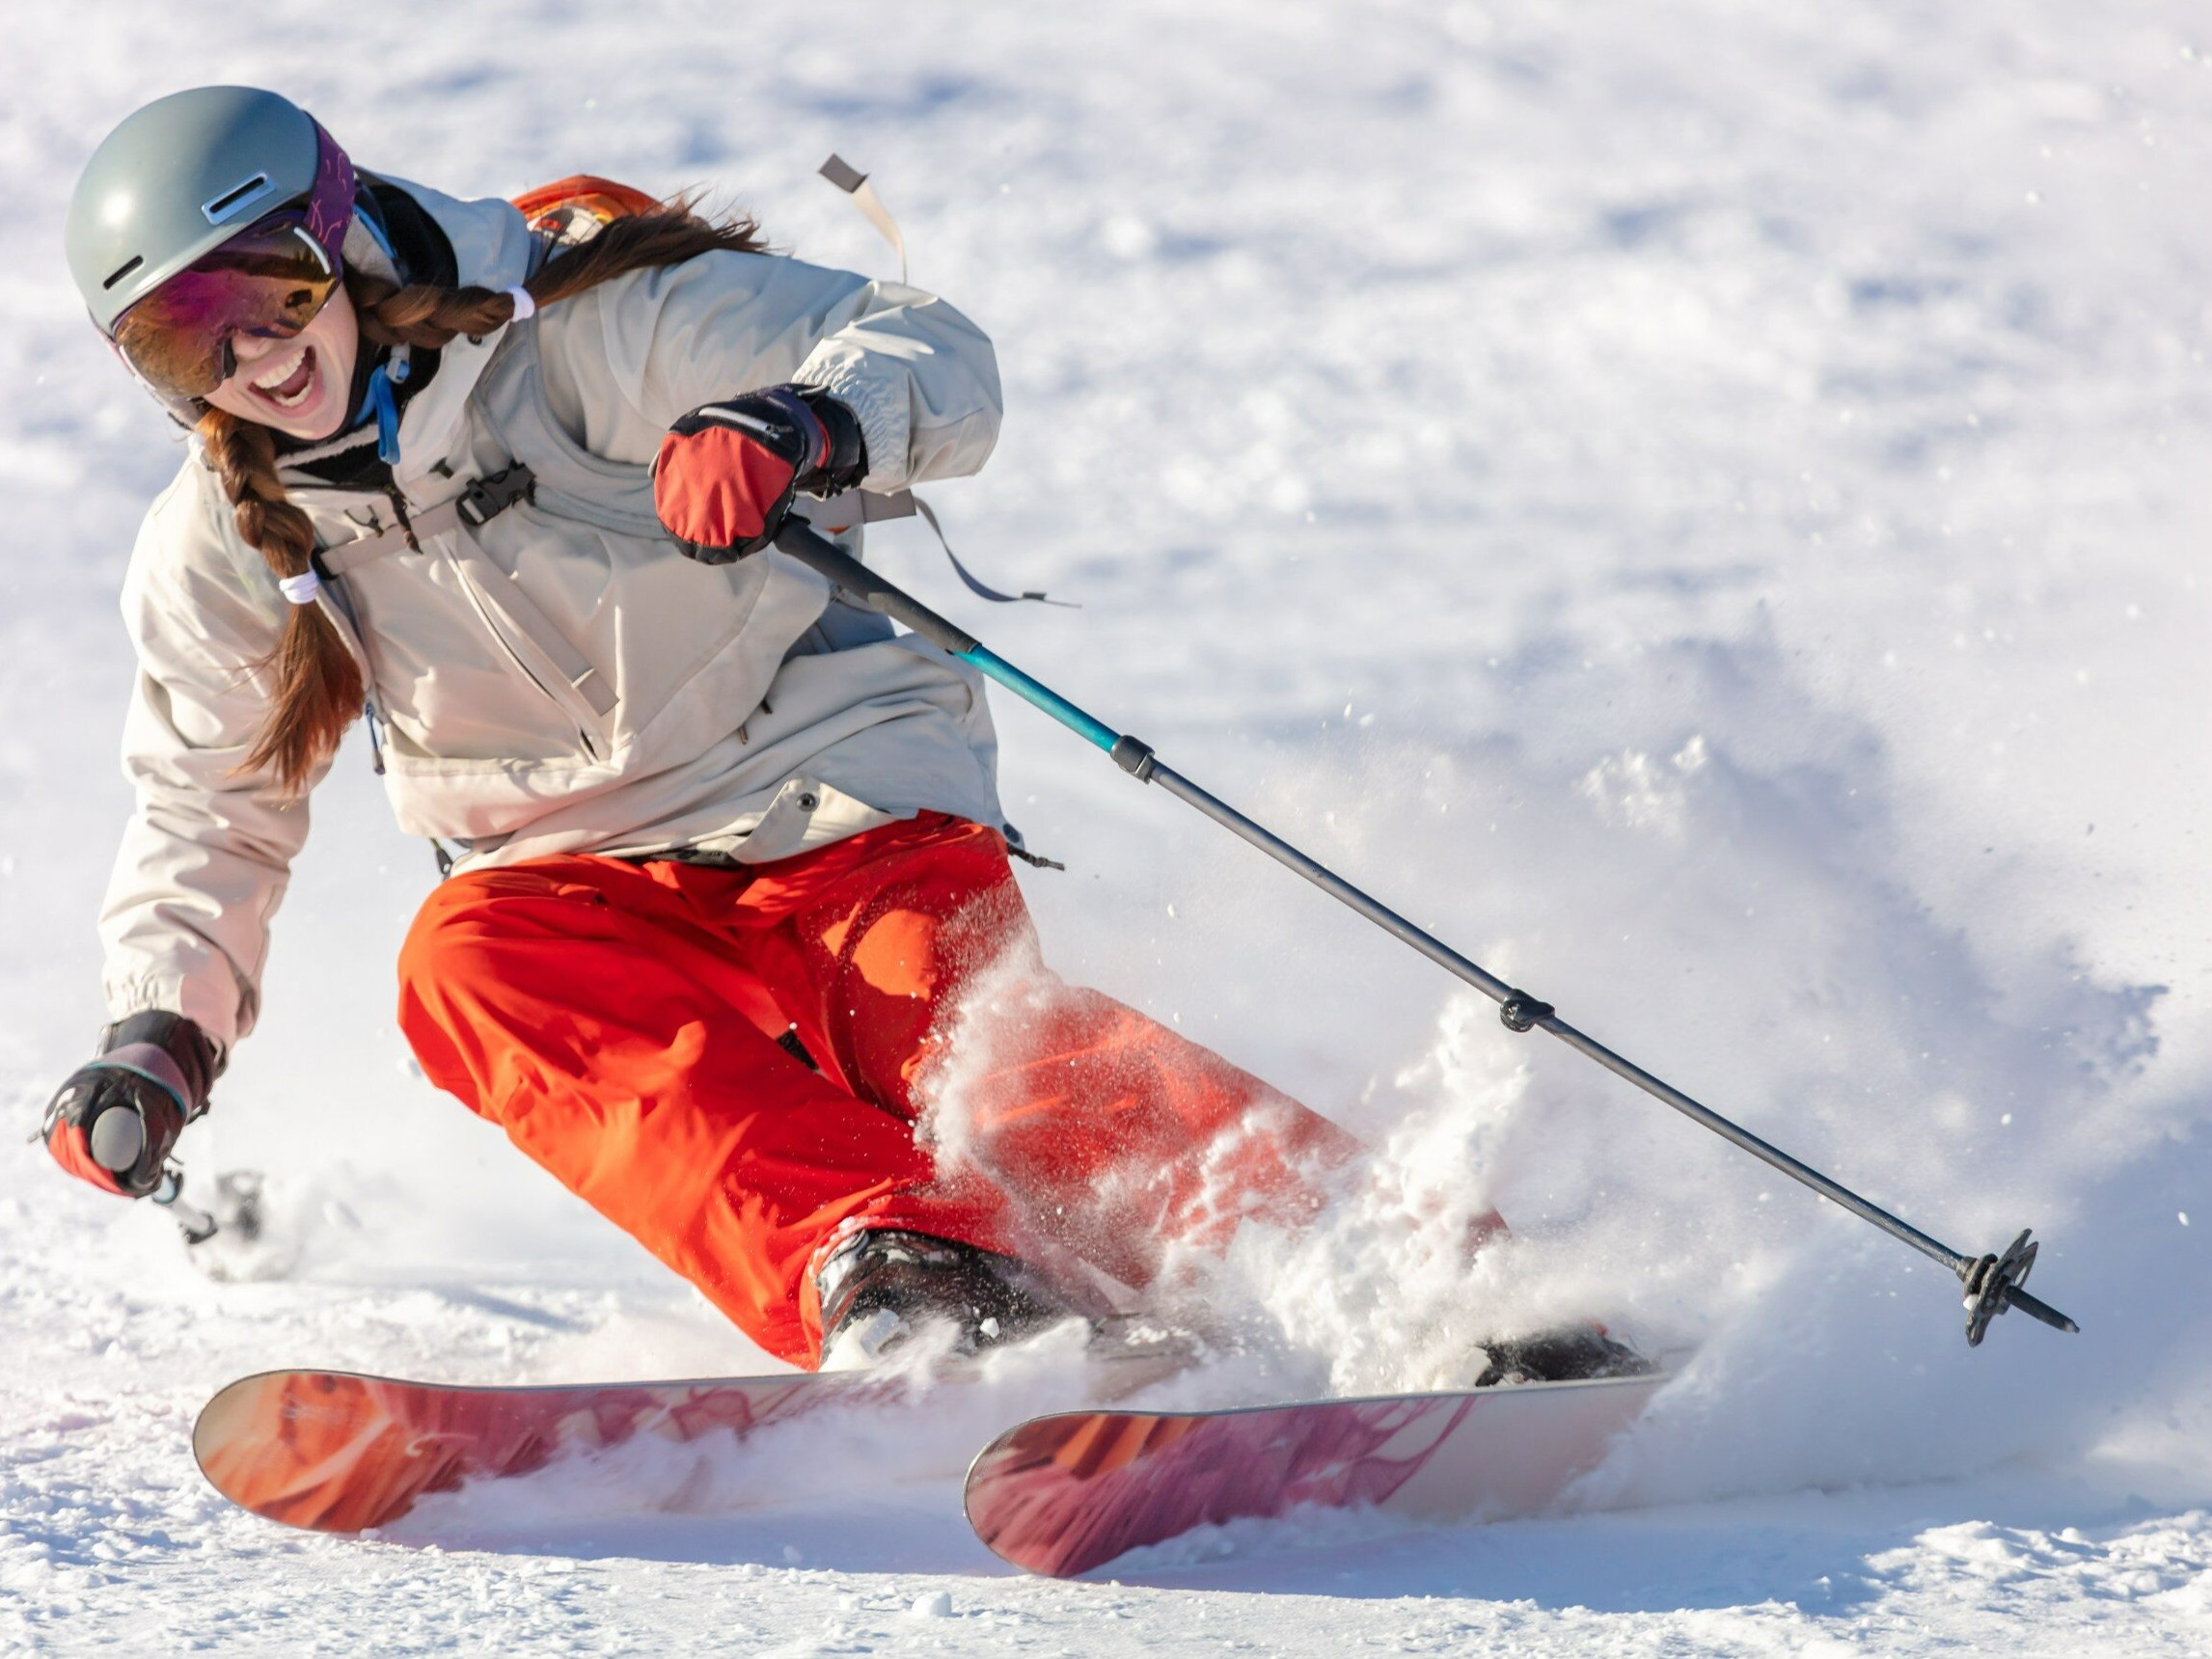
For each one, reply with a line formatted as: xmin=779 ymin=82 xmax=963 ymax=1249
xmin=0 ymin=0 xmax=2212 ymax=1654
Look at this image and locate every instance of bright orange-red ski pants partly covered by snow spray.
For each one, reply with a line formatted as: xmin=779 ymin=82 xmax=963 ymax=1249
xmin=400 ymin=814 xmax=1356 ymax=1365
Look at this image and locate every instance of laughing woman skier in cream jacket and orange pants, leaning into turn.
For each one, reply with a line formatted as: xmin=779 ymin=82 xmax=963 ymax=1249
xmin=44 ymin=86 xmax=1352 ymax=1365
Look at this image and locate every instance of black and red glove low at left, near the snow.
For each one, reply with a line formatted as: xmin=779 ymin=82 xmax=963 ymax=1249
xmin=42 ymin=1013 xmax=221 ymax=1199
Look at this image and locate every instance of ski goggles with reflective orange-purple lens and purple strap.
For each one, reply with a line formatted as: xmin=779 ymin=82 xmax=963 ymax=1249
xmin=111 ymin=126 xmax=354 ymax=400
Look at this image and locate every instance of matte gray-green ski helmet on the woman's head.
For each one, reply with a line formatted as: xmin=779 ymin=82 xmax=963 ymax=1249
xmin=62 ymin=86 xmax=334 ymax=339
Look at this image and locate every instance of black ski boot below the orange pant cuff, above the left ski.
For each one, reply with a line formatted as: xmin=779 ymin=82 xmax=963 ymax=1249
xmin=814 ymin=1228 xmax=1078 ymax=1372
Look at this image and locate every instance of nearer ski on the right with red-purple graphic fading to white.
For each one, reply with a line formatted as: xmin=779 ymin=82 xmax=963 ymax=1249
xmin=967 ymin=1373 xmax=1666 ymax=1577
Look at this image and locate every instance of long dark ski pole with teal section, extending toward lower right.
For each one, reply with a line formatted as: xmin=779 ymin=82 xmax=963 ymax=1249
xmin=777 ymin=518 xmax=2082 ymax=1347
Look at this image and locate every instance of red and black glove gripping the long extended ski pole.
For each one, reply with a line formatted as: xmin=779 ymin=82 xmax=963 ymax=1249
xmin=652 ymin=385 xmax=867 ymax=564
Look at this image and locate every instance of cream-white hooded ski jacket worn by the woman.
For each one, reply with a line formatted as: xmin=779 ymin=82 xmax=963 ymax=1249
xmin=101 ymin=186 xmax=999 ymax=1048
